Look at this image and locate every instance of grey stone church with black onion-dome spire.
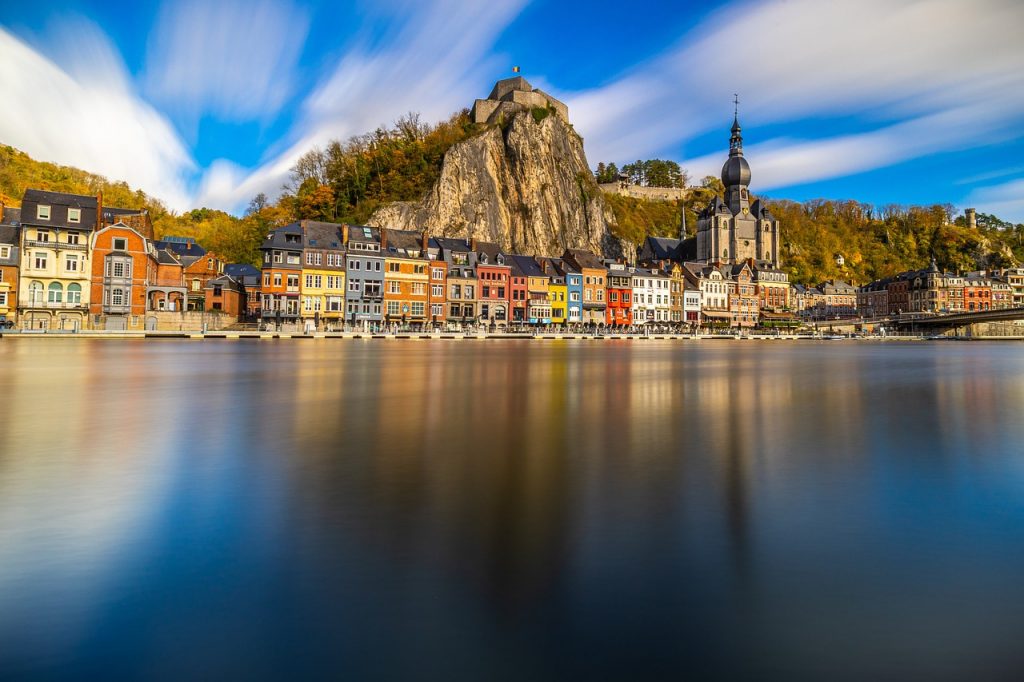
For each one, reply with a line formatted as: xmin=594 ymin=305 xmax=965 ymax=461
xmin=696 ymin=112 xmax=780 ymax=269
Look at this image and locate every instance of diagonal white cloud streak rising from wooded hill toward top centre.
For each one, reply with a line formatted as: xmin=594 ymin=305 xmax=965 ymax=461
xmin=199 ymin=0 xmax=525 ymax=208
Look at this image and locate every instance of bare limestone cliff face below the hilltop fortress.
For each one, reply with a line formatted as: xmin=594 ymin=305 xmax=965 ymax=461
xmin=368 ymin=112 xmax=623 ymax=257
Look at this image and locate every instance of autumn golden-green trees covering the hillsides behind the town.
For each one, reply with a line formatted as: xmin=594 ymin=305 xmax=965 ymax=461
xmin=0 ymin=124 xmax=1024 ymax=284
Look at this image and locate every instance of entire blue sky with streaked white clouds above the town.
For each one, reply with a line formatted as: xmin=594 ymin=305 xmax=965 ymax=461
xmin=0 ymin=0 xmax=1024 ymax=221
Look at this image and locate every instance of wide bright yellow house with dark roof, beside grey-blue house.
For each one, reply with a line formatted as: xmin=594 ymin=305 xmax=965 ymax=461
xmin=299 ymin=220 xmax=345 ymax=330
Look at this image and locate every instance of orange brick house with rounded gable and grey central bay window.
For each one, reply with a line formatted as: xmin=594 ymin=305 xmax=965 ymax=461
xmin=89 ymin=223 xmax=156 ymax=329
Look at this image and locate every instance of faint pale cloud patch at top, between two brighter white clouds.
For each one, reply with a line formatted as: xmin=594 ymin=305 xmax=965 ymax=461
xmin=142 ymin=0 xmax=309 ymax=123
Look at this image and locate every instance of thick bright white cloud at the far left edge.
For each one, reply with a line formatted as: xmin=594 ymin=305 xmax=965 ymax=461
xmin=0 ymin=19 xmax=196 ymax=209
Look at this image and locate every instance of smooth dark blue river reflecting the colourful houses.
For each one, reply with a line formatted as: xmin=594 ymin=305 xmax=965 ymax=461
xmin=0 ymin=339 xmax=1024 ymax=680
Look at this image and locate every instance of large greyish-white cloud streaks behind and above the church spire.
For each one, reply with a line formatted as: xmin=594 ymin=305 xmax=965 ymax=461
xmin=565 ymin=0 xmax=1024 ymax=187
